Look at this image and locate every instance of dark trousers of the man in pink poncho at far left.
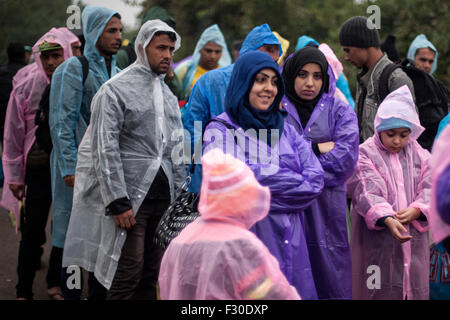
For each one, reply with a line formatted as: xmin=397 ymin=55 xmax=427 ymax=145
xmin=16 ymin=166 xmax=62 ymax=299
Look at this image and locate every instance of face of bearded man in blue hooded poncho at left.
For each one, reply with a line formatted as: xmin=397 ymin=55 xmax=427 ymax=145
xmin=96 ymin=17 xmax=122 ymax=56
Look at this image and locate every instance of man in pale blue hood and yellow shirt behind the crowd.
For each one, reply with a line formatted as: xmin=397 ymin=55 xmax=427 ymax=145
xmin=175 ymin=24 xmax=231 ymax=100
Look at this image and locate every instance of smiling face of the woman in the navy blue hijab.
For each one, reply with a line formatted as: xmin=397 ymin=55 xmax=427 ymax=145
xmin=248 ymin=68 xmax=279 ymax=111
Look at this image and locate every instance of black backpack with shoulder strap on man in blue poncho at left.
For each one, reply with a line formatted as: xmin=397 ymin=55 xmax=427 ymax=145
xmin=34 ymin=56 xmax=89 ymax=154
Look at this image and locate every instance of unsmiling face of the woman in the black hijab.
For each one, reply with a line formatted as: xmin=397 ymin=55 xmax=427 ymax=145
xmin=294 ymin=63 xmax=323 ymax=100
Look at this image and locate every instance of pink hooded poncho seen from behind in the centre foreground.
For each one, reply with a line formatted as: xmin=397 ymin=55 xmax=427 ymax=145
xmin=159 ymin=149 xmax=300 ymax=300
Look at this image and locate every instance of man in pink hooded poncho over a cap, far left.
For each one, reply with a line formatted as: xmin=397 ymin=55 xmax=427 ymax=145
xmin=1 ymin=28 xmax=72 ymax=300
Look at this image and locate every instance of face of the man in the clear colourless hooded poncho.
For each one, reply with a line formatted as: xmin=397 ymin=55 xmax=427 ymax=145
xmin=145 ymin=34 xmax=175 ymax=74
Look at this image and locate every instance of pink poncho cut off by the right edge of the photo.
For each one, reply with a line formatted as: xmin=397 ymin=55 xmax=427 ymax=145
xmin=430 ymin=125 xmax=450 ymax=243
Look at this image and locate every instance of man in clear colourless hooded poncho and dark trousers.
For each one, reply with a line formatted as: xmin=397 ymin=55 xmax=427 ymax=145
xmin=63 ymin=20 xmax=185 ymax=299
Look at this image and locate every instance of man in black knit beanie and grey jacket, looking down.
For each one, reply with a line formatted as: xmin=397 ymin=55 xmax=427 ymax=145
xmin=339 ymin=16 xmax=417 ymax=143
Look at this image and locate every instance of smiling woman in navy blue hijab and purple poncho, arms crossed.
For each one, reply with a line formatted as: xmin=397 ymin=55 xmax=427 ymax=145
xmin=203 ymin=51 xmax=323 ymax=299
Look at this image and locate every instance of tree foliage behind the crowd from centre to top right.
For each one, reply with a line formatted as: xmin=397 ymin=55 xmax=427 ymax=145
xmin=142 ymin=0 xmax=450 ymax=92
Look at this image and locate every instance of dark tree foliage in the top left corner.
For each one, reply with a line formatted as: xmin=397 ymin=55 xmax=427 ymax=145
xmin=0 ymin=0 xmax=72 ymax=65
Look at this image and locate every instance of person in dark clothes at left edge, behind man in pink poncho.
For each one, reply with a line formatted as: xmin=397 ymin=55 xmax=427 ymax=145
xmin=0 ymin=42 xmax=25 ymax=145
